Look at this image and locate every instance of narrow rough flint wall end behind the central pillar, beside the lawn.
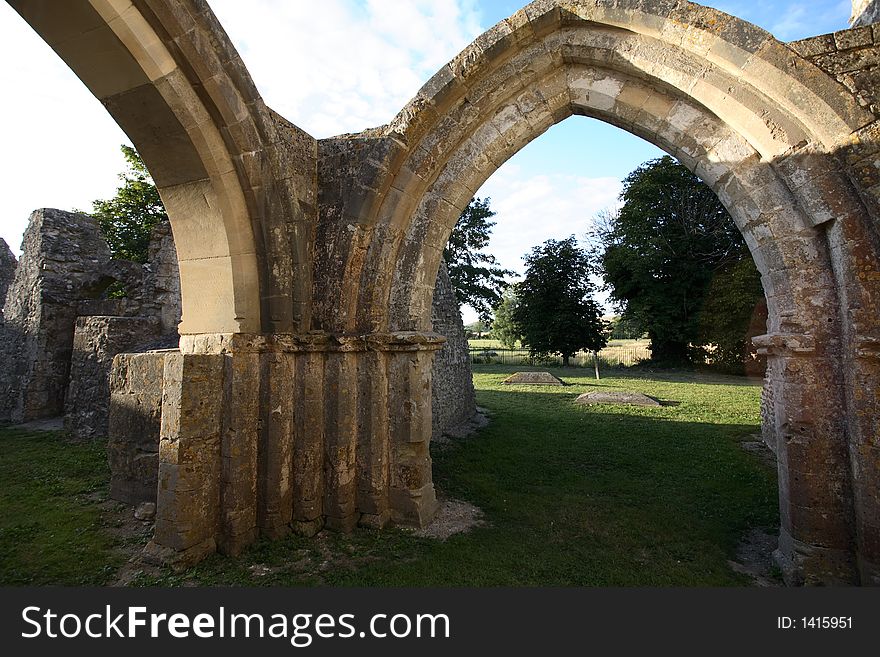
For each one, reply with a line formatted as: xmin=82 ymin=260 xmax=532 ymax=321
xmin=431 ymin=262 xmax=477 ymax=438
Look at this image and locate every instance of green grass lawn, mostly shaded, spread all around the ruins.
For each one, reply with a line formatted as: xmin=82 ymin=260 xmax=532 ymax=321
xmin=0 ymin=366 xmax=778 ymax=586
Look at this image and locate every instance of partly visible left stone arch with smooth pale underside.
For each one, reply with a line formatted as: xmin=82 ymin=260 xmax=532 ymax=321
xmin=11 ymin=0 xmax=314 ymax=336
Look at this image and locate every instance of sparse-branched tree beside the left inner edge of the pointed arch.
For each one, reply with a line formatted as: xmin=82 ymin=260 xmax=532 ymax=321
xmin=443 ymin=198 xmax=514 ymax=323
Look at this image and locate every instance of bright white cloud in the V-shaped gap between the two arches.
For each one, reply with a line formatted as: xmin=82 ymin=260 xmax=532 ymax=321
xmin=211 ymin=0 xmax=481 ymax=138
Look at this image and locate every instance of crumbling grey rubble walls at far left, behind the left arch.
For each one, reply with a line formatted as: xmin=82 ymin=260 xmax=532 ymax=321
xmin=0 ymin=209 xmax=180 ymax=430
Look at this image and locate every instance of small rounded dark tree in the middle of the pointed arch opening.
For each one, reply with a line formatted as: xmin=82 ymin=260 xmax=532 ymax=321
xmin=513 ymin=235 xmax=606 ymax=366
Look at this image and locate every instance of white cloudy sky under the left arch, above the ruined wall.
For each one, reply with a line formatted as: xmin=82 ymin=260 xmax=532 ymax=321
xmin=0 ymin=2 xmax=127 ymax=253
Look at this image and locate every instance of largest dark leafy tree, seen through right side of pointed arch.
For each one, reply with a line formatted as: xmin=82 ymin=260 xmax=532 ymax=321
xmin=597 ymin=156 xmax=762 ymax=364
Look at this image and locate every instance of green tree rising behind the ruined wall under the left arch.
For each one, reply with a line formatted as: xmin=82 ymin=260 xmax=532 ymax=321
xmin=90 ymin=145 xmax=168 ymax=263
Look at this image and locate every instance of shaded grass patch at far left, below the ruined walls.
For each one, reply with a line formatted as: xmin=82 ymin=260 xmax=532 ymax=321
xmin=0 ymin=429 xmax=122 ymax=586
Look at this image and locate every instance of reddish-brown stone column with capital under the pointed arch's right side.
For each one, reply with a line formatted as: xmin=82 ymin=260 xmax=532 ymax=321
xmin=755 ymin=333 xmax=858 ymax=585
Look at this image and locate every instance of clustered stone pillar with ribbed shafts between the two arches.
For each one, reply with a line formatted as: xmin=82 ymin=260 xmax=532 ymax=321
xmin=147 ymin=332 xmax=444 ymax=566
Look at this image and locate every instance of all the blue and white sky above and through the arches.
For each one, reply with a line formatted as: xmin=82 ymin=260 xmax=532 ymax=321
xmin=0 ymin=0 xmax=850 ymax=319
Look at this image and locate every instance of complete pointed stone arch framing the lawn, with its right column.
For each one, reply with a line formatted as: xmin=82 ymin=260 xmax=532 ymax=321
xmin=325 ymin=0 xmax=880 ymax=582
